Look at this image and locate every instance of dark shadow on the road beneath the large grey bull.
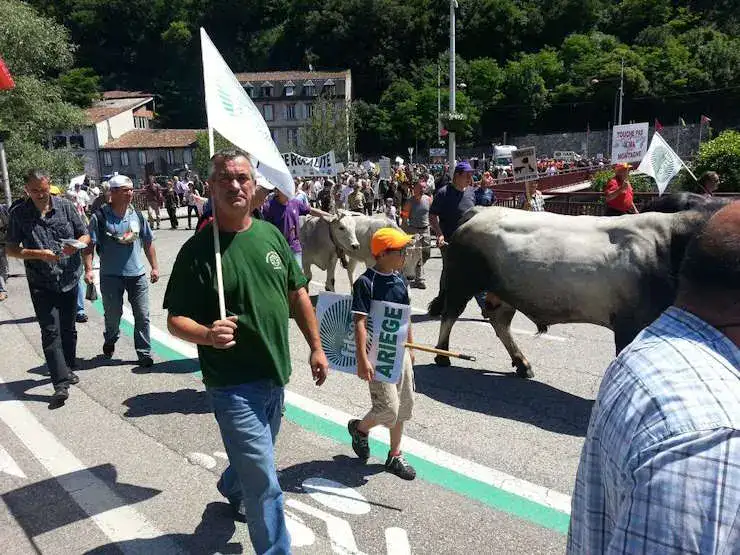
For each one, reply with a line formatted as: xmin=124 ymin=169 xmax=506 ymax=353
xmin=414 ymin=364 xmax=594 ymax=436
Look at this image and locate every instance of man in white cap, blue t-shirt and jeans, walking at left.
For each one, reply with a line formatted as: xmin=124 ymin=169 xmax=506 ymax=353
xmin=85 ymin=175 xmax=159 ymax=368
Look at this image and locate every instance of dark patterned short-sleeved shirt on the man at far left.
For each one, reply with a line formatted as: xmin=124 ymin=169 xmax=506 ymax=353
xmin=7 ymin=196 xmax=87 ymax=293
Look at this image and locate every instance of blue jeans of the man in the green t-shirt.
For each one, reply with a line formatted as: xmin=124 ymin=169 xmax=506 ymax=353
xmin=207 ymin=380 xmax=290 ymax=554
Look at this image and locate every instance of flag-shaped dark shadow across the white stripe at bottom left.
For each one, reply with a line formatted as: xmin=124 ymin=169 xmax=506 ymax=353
xmin=2 ymin=464 xmax=160 ymax=540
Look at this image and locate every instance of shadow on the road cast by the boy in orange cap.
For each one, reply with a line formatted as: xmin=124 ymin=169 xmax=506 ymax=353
xmin=280 ymin=455 xmax=401 ymax=511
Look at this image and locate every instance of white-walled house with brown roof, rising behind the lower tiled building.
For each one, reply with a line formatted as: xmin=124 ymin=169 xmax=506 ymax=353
xmin=49 ymin=91 xmax=155 ymax=182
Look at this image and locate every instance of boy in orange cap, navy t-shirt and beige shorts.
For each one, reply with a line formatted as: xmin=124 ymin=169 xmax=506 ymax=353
xmin=347 ymin=227 xmax=416 ymax=480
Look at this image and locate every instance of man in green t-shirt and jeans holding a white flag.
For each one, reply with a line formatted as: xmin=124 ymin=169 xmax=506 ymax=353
xmin=164 ymin=151 xmax=329 ymax=553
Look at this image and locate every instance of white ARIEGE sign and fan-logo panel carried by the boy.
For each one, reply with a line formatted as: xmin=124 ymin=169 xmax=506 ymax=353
xmin=316 ymin=292 xmax=411 ymax=383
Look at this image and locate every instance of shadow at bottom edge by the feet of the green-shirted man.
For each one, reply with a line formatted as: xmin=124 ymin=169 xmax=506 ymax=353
xmin=85 ymin=502 xmax=244 ymax=555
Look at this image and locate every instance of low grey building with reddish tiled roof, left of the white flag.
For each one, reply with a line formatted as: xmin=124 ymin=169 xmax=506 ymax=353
xmin=100 ymin=129 xmax=199 ymax=184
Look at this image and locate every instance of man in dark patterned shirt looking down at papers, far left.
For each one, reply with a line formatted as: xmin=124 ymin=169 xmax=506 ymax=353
xmin=6 ymin=170 xmax=90 ymax=407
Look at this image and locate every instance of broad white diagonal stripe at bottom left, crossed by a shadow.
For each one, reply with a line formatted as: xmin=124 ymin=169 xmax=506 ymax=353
xmin=0 ymin=378 xmax=181 ymax=554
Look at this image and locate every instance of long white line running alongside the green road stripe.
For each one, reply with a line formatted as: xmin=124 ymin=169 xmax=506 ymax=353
xmin=114 ymin=292 xmax=570 ymax=514
